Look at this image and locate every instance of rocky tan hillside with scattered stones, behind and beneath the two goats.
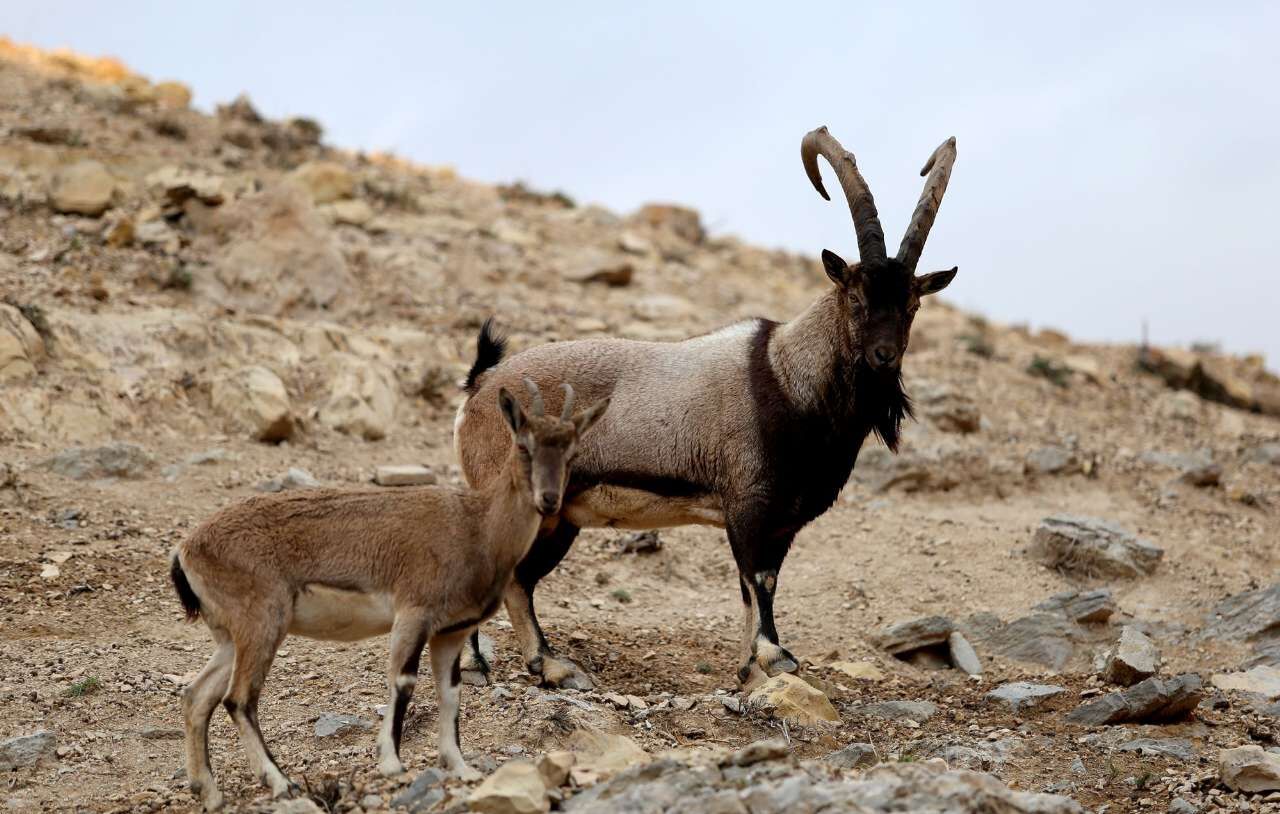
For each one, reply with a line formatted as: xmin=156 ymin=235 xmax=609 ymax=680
xmin=0 ymin=41 xmax=1280 ymax=814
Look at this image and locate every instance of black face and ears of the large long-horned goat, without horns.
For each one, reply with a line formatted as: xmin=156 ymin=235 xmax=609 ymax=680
xmin=822 ymin=251 xmax=956 ymax=371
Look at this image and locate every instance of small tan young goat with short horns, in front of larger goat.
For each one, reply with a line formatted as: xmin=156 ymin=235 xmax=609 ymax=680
xmin=172 ymin=380 xmax=608 ymax=809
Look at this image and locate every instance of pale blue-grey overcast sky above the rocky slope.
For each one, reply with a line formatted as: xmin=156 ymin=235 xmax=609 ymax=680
xmin=10 ymin=0 xmax=1280 ymax=369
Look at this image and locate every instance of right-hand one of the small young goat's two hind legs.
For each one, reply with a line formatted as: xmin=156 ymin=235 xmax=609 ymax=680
xmin=223 ymin=614 xmax=294 ymax=797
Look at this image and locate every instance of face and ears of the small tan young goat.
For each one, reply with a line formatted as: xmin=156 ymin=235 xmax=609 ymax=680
xmin=498 ymin=388 xmax=609 ymax=517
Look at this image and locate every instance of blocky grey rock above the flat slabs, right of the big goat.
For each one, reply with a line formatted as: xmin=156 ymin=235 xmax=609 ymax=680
xmin=1028 ymin=515 xmax=1165 ymax=577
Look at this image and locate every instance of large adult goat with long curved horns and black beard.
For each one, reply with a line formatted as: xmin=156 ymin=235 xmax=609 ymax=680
xmin=454 ymin=127 xmax=956 ymax=687
